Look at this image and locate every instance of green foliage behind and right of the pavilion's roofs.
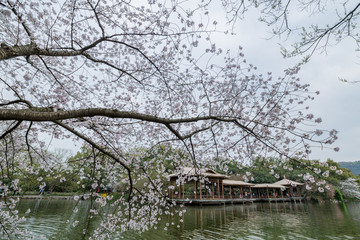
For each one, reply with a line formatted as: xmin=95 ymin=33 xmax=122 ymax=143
xmin=218 ymin=158 xmax=360 ymax=200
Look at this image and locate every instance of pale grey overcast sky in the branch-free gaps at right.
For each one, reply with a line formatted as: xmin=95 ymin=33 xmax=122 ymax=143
xmin=225 ymin=7 xmax=360 ymax=161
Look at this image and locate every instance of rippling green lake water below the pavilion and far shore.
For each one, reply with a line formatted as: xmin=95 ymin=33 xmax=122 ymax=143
xmin=17 ymin=199 xmax=360 ymax=240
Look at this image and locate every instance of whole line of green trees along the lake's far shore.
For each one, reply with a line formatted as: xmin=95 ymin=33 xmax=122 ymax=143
xmin=1 ymin=145 xmax=360 ymax=201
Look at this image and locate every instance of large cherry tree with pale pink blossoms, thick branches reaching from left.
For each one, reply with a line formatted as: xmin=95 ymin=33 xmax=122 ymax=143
xmin=0 ymin=0 xmax=336 ymax=237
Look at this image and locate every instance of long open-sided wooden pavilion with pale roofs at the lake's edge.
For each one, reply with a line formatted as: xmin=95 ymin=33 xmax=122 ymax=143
xmin=168 ymin=167 xmax=303 ymax=204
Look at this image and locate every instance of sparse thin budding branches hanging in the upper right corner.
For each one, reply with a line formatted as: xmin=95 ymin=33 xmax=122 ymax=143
xmin=223 ymin=0 xmax=360 ymax=61
